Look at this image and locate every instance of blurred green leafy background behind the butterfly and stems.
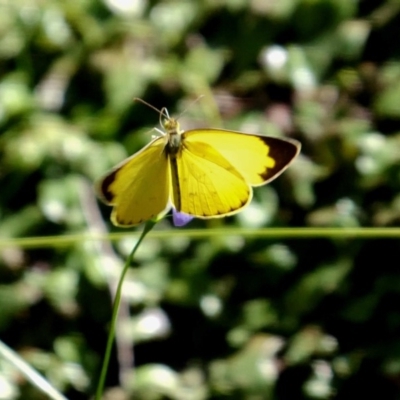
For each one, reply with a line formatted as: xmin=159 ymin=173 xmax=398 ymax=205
xmin=0 ymin=0 xmax=400 ymax=400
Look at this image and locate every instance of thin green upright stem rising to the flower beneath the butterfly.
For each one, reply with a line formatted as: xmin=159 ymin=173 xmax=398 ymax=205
xmin=95 ymin=220 xmax=157 ymax=400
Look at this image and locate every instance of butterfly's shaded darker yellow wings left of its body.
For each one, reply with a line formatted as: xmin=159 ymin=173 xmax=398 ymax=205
xmin=96 ymin=137 xmax=170 ymax=227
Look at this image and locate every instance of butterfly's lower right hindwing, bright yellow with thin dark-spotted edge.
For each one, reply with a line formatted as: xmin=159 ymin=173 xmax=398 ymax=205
xmin=170 ymin=141 xmax=252 ymax=218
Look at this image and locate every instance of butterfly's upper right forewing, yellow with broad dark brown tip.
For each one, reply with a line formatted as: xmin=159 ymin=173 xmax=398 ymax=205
xmin=182 ymin=129 xmax=301 ymax=186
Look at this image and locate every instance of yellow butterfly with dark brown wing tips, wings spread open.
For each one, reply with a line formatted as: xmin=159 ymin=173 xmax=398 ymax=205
xmin=96 ymin=104 xmax=301 ymax=227
